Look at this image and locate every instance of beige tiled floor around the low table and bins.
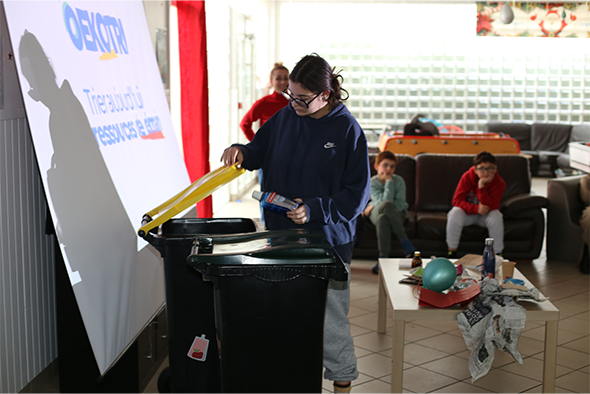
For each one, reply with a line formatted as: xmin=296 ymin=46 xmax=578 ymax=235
xmin=145 ymin=178 xmax=590 ymax=393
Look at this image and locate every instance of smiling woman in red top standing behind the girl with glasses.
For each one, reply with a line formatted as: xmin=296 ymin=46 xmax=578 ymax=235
xmin=240 ymin=63 xmax=289 ymax=141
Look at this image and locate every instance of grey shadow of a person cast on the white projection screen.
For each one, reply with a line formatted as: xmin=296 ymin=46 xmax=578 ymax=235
xmin=19 ymin=31 xmax=138 ymax=370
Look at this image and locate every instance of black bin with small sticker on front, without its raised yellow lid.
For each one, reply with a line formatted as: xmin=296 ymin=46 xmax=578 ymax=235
xmin=144 ymin=218 xmax=256 ymax=393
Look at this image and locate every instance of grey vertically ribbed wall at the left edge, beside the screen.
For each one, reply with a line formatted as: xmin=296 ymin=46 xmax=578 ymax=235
xmin=0 ymin=4 xmax=57 ymax=393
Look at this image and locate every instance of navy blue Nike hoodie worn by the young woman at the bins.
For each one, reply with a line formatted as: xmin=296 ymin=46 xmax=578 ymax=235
xmin=238 ymin=103 xmax=371 ymax=246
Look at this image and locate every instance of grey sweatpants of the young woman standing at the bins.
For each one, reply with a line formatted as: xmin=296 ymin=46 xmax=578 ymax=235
xmin=324 ymin=243 xmax=359 ymax=382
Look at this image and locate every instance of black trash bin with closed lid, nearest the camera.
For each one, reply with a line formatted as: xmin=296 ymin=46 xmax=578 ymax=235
xmin=188 ymin=230 xmax=348 ymax=393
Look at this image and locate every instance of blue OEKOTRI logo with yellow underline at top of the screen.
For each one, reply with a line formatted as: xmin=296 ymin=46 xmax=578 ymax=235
xmin=62 ymin=3 xmax=129 ymax=60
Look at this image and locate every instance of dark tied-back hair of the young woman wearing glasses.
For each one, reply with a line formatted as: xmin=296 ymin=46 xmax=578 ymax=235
xmin=289 ymin=53 xmax=349 ymax=107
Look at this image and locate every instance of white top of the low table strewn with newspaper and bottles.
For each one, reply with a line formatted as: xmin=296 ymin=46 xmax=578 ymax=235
xmin=379 ymin=259 xmax=559 ymax=321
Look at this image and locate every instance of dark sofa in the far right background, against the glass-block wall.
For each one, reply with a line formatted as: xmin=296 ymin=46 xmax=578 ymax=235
xmin=485 ymin=122 xmax=590 ymax=178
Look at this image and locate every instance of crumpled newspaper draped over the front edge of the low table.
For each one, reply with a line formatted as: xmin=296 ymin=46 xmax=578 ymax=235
xmin=457 ymin=278 xmax=546 ymax=383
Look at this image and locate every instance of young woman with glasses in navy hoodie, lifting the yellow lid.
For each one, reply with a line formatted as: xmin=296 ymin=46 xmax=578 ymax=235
xmin=221 ymin=54 xmax=370 ymax=392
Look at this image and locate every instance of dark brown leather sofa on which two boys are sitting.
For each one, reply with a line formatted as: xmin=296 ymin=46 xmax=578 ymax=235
xmin=354 ymin=153 xmax=548 ymax=260
